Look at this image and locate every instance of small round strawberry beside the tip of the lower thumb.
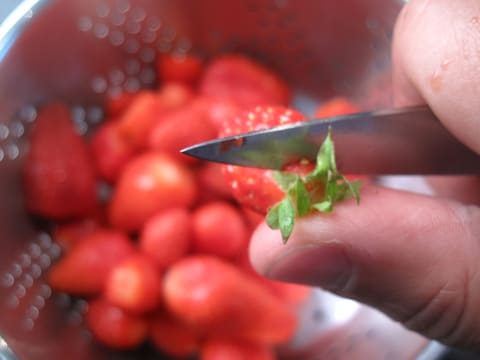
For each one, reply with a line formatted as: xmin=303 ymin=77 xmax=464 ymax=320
xmin=192 ymin=201 xmax=249 ymax=258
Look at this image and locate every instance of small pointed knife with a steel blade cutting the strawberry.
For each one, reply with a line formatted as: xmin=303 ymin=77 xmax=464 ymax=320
xmin=182 ymin=106 xmax=480 ymax=175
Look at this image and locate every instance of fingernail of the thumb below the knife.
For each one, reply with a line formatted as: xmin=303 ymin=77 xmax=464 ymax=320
xmin=265 ymin=243 xmax=352 ymax=291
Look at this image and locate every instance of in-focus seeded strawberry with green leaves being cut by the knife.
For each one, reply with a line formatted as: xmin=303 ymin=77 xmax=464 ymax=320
xmin=220 ymin=106 xmax=359 ymax=241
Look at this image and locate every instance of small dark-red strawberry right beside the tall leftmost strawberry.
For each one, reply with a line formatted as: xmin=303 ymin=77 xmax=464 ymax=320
xmin=91 ymin=121 xmax=135 ymax=183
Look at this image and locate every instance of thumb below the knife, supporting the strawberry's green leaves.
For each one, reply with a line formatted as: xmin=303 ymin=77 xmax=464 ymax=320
xmin=250 ymin=187 xmax=480 ymax=347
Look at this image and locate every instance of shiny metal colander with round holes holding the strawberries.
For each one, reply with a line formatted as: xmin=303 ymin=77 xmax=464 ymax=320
xmin=0 ymin=0 xmax=450 ymax=360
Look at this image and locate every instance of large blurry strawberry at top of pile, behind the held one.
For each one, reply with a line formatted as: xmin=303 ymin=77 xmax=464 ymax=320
xmin=200 ymin=54 xmax=290 ymax=108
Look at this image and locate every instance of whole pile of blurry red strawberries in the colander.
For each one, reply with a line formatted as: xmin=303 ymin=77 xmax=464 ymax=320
xmin=23 ymin=55 xmax=356 ymax=360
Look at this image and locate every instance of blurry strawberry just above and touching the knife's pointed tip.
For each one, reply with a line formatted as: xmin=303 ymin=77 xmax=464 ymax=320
xmin=148 ymin=99 xmax=216 ymax=163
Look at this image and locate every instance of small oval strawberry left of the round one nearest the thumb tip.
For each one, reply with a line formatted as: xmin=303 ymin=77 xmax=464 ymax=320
xmin=139 ymin=208 xmax=192 ymax=270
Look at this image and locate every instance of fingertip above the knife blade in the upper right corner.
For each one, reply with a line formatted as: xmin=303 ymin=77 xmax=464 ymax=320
xmin=393 ymin=0 xmax=480 ymax=153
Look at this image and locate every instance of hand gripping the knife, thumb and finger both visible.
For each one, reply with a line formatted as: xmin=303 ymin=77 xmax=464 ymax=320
xmin=250 ymin=0 xmax=480 ymax=350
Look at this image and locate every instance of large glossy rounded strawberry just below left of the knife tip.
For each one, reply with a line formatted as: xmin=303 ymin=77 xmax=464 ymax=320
xmin=109 ymin=152 xmax=198 ymax=231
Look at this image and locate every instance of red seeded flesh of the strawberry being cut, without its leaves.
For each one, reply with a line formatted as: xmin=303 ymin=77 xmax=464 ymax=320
xmin=220 ymin=106 xmax=306 ymax=213
